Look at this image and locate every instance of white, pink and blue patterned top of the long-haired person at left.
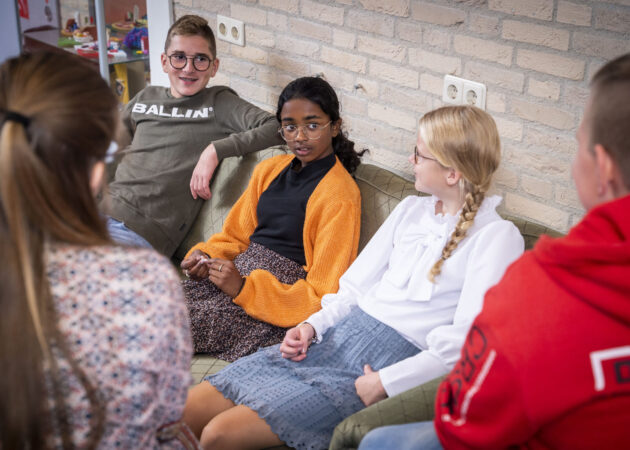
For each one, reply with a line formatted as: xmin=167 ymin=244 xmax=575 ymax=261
xmin=46 ymin=244 xmax=192 ymax=449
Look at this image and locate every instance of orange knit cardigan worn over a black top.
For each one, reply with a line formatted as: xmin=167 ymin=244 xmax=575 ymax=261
xmin=188 ymin=155 xmax=361 ymax=327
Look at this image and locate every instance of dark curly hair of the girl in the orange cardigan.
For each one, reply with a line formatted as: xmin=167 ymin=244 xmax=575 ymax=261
xmin=276 ymin=77 xmax=367 ymax=174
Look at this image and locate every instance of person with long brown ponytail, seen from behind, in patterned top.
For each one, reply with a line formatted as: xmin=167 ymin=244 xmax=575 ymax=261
xmin=0 ymin=53 xmax=196 ymax=450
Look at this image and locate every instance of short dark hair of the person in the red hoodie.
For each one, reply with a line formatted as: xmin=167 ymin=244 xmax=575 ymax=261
xmin=585 ymin=53 xmax=630 ymax=189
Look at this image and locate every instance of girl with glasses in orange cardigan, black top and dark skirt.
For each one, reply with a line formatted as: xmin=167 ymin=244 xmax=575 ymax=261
xmin=181 ymin=77 xmax=361 ymax=361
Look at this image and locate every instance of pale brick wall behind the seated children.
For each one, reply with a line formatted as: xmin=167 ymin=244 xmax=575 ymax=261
xmin=174 ymin=0 xmax=630 ymax=231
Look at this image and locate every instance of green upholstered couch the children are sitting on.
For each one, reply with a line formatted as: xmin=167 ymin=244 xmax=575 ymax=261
xmin=174 ymin=146 xmax=559 ymax=449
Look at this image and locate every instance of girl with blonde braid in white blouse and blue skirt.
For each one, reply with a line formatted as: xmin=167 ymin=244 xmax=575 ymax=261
xmin=184 ymin=106 xmax=523 ymax=449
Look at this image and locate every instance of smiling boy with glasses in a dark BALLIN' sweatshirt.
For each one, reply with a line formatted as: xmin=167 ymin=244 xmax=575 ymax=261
xmin=107 ymin=15 xmax=283 ymax=256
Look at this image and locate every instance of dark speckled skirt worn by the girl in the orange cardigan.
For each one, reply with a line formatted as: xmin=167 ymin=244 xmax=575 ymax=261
xmin=182 ymin=242 xmax=306 ymax=362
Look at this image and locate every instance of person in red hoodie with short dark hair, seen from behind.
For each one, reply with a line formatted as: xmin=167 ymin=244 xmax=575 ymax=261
xmin=360 ymin=54 xmax=630 ymax=450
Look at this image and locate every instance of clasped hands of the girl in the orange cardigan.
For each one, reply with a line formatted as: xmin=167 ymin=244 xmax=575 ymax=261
xmin=180 ymin=250 xmax=244 ymax=298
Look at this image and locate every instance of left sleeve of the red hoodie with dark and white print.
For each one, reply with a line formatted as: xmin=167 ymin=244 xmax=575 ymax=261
xmin=435 ymin=318 xmax=532 ymax=449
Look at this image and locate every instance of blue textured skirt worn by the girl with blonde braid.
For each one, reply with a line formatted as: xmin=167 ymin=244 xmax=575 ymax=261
xmin=206 ymin=307 xmax=420 ymax=449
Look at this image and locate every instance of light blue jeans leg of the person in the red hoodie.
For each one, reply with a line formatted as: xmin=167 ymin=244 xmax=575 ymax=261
xmin=359 ymin=421 xmax=442 ymax=450
